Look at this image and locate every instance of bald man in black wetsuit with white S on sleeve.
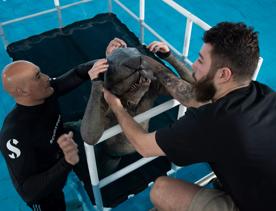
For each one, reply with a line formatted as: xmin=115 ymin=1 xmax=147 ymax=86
xmin=0 ymin=39 xmax=125 ymax=211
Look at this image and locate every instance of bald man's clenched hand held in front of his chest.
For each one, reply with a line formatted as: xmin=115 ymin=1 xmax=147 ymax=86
xmin=57 ymin=131 xmax=79 ymax=165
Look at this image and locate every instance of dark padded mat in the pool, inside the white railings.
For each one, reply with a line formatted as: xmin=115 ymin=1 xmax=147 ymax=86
xmin=7 ymin=13 xmax=176 ymax=206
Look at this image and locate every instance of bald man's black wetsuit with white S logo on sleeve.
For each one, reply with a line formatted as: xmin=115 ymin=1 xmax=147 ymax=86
xmin=0 ymin=61 xmax=94 ymax=211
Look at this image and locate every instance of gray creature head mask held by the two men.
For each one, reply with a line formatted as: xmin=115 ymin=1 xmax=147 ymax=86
xmin=104 ymin=48 xmax=154 ymax=106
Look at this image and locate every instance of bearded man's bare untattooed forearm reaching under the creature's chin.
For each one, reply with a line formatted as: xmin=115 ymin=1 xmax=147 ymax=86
xmin=104 ymin=89 xmax=165 ymax=157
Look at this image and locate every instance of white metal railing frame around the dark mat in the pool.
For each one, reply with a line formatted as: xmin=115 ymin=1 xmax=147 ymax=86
xmin=0 ymin=0 xmax=263 ymax=211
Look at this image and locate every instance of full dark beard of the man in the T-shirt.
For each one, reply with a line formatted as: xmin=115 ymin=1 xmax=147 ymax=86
xmin=194 ymin=70 xmax=217 ymax=102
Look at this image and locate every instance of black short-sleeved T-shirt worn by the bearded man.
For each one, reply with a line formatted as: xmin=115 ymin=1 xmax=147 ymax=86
xmin=156 ymin=82 xmax=276 ymax=211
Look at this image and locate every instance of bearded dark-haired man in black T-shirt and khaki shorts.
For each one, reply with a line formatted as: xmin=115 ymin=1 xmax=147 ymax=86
xmin=104 ymin=22 xmax=276 ymax=211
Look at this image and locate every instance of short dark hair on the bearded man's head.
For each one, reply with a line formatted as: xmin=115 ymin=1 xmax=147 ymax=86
xmin=203 ymin=22 xmax=260 ymax=81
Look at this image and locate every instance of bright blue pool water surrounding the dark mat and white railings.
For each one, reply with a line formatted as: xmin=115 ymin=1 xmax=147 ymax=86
xmin=0 ymin=0 xmax=276 ymax=210
